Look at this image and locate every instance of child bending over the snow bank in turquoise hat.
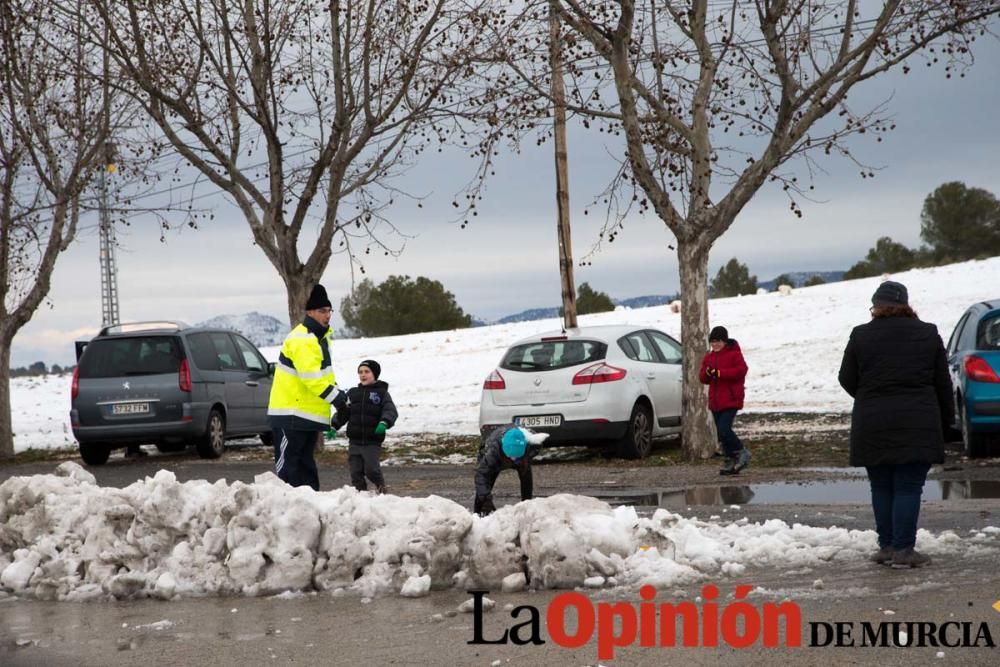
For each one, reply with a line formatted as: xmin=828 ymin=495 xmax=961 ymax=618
xmin=473 ymin=424 xmax=549 ymax=516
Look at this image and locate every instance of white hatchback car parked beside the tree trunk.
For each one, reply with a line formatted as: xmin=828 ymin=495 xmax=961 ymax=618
xmin=479 ymin=326 xmax=682 ymax=458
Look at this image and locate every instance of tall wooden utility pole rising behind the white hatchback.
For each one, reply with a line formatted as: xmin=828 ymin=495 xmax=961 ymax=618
xmin=549 ymin=4 xmax=576 ymax=329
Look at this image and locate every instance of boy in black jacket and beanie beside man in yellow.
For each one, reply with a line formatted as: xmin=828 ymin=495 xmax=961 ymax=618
xmin=330 ymin=359 xmax=398 ymax=493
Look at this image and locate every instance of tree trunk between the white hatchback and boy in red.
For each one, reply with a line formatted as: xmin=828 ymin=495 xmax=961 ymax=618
xmin=677 ymin=239 xmax=717 ymax=461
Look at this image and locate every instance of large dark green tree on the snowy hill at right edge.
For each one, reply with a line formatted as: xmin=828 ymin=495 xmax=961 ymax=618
xmin=920 ymin=181 xmax=1000 ymax=264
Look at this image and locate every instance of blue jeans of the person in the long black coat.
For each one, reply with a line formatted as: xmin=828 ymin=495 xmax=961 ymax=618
xmin=865 ymin=463 xmax=931 ymax=550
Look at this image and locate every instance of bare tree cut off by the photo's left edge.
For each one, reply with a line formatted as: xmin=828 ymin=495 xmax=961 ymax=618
xmin=0 ymin=0 xmax=111 ymax=459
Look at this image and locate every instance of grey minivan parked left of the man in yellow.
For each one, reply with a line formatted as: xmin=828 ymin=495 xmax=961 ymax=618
xmin=70 ymin=322 xmax=274 ymax=465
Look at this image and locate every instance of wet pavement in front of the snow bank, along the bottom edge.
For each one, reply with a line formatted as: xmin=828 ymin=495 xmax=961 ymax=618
xmin=0 ymin=555 xmax=1000 ymax=667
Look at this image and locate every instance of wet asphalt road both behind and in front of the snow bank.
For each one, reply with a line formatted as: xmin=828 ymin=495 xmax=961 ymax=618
xmin=0 ymin=454 xmax=1000 ymax=666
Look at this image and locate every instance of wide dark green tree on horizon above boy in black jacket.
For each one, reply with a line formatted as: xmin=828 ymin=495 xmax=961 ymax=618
xmin=340 ymin=276 xmax=472 ymax=337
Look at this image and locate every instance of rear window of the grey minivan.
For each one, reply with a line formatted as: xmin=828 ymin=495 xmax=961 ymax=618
xmin=80 ymin=336 xmax=183 ymax=379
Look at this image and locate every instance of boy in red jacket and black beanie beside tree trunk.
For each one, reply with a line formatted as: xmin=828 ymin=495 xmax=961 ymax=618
xmin=699 ymin=327 xmax=750 ymax=475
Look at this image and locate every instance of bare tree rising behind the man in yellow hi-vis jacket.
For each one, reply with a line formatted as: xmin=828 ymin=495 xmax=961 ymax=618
xmin=87 ymin=0 xmax=504 ymax=322
